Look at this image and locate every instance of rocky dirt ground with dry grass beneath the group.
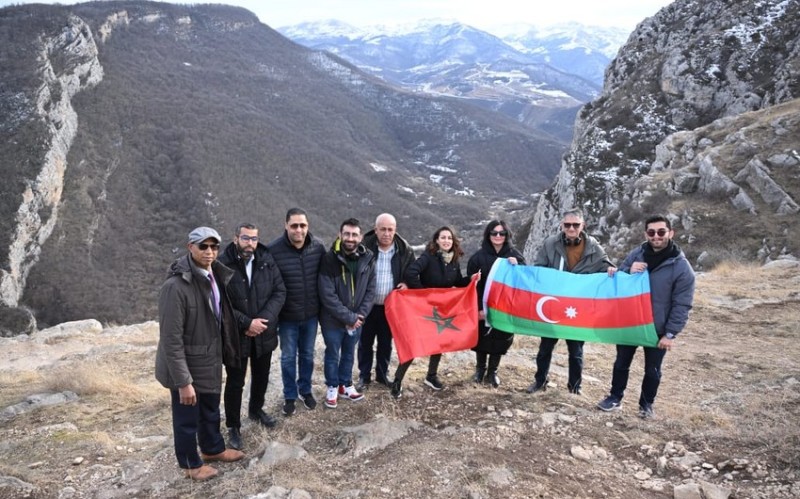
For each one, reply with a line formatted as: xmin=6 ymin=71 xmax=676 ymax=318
xmin=0 ymin=262 xmax=800 ymax=498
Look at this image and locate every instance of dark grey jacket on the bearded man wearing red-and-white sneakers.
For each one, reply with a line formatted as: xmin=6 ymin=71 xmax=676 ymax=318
xmin=319 ymin=239 xmax=376 ymax=329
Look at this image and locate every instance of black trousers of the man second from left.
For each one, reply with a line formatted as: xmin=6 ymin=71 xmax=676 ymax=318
xmin=225 ymin=344 xmax=272 ymax=428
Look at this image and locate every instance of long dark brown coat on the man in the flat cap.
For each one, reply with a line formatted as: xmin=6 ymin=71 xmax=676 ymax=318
xmin=155 ymin=254 xmax=240 ymax=393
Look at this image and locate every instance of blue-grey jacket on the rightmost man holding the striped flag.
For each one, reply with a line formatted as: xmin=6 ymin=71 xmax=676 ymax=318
xmin=619 ymin=243 xmax=694 ymax=338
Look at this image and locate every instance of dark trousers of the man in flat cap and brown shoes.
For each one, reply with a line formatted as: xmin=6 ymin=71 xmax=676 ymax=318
xmin=170 ymin=390 xmax=225 ymax=469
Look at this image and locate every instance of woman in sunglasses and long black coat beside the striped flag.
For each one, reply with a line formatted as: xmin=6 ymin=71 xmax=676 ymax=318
xmin=467 ymin=220 xmax=525 ymax=388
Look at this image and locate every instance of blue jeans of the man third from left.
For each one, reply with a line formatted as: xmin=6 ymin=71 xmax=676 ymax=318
xmin=278 ymin=317 xmax=317 ymax=400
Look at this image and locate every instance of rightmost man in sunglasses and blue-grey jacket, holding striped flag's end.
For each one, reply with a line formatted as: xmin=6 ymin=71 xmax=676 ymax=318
xmin=597 ymin=215 xmax=695 ymax=419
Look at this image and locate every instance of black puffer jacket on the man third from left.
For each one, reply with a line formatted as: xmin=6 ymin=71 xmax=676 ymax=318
xmin=267 ymin=231 xmax=325 ymax=321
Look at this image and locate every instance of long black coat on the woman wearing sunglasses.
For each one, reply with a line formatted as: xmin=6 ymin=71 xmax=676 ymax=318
xmin=467 ymin=241 xmax=525 ymax=355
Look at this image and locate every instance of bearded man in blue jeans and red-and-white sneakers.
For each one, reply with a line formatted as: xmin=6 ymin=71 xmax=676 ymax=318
xmin=319 ymin=218 xmax=375 ymax=409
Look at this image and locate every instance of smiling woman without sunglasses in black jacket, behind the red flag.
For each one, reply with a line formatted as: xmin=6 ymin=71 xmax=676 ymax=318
xmin=392 ymin=226 xmax=470 ymax=398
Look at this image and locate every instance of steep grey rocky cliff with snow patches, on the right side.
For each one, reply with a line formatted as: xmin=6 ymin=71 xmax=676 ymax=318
xmin=525 ymin=0 xmax=800 ymax=268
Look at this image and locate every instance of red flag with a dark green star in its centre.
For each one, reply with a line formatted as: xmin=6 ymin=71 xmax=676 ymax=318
xmin=384 ymin=275 xmax=478 ymax=364
